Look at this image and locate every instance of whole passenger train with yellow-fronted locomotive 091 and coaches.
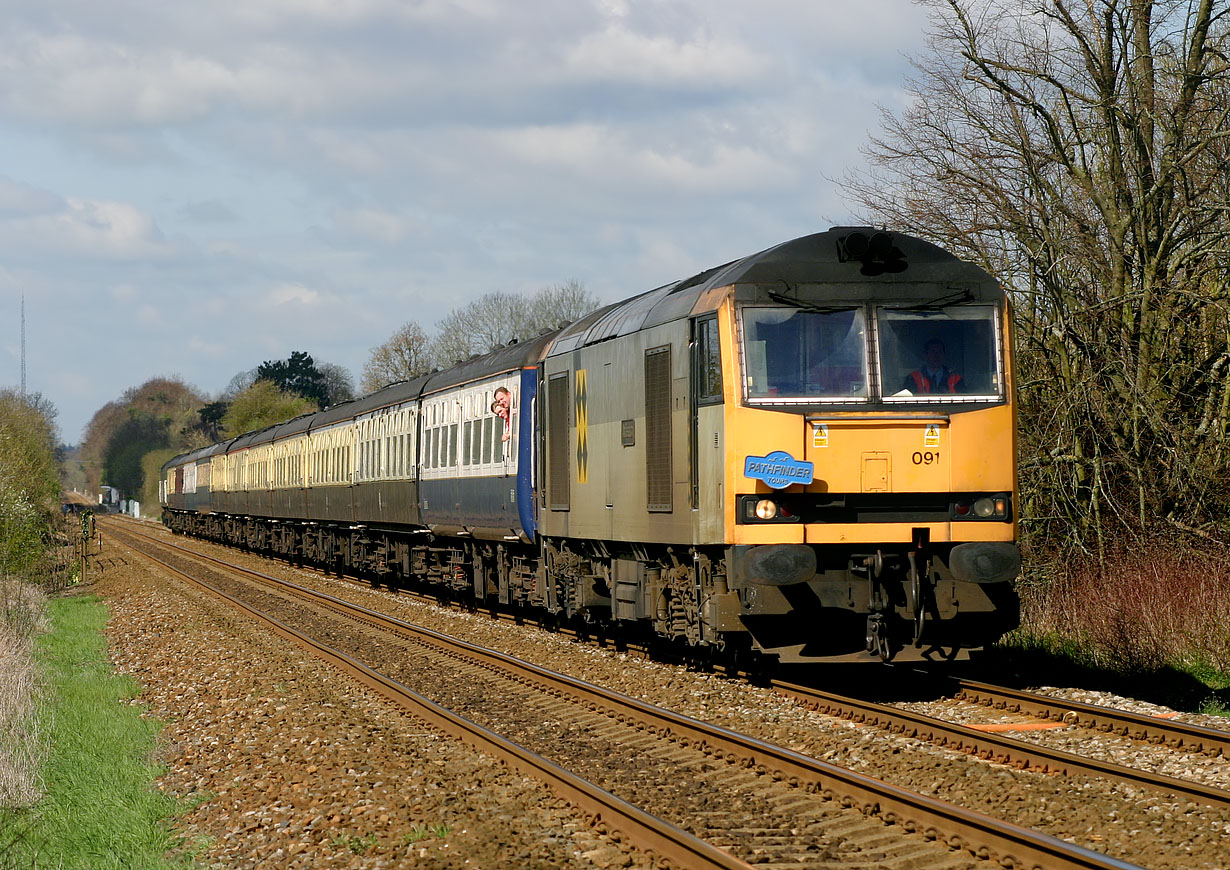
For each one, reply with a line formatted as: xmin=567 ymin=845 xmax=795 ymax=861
xmin=160 ymin=228 xmax=1021 ymax=662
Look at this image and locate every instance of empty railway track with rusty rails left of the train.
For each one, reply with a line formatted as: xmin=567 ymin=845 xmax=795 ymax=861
xmin=105 ymin=516 xmax=1133 ymax=868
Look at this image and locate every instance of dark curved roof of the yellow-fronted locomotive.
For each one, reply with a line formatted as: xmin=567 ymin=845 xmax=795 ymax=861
xmin=547 ymin=226 xmax=1002 ymax=357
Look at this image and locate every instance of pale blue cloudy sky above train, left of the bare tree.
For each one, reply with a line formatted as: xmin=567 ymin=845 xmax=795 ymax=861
xmin=0 ymin=0 xmax=927 ymax=444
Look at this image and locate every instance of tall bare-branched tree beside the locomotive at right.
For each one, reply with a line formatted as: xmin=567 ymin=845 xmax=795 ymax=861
xmin=844 ymin=0 xmax=1230 ymax=558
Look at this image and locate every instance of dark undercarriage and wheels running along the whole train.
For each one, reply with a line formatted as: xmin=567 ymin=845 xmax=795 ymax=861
xmin=158 ymin=509 xmax=1018 ymax=662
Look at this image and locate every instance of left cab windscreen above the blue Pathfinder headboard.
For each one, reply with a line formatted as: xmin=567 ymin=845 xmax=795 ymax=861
xmin=742 ymin=306 xmax=868 ymax=402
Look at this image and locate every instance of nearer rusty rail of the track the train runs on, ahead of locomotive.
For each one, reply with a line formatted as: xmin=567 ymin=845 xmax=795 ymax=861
xmin=772 ymin=680 xmax=1230 ymax=807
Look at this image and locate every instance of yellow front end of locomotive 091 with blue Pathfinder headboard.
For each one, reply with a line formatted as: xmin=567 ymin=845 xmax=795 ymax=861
xmin=701 ymin=229 xmax=1020 ymax=661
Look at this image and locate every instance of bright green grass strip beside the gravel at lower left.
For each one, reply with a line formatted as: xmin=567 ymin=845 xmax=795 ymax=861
xmin=0 ymin=597 xmax=182 ymax=870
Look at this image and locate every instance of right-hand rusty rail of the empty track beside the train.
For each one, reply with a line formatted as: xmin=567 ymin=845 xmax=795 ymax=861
xmin=115 ymin=524 xmax=1139 ymax=870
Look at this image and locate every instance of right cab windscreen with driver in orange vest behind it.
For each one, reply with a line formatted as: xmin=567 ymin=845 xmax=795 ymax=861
xmin=877 ymin=305 xmax=1004 ymax=402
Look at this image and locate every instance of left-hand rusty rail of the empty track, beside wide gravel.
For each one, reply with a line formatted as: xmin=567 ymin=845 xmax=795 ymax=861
xmin=113 ymin=526 xmax=754 ymax=870
